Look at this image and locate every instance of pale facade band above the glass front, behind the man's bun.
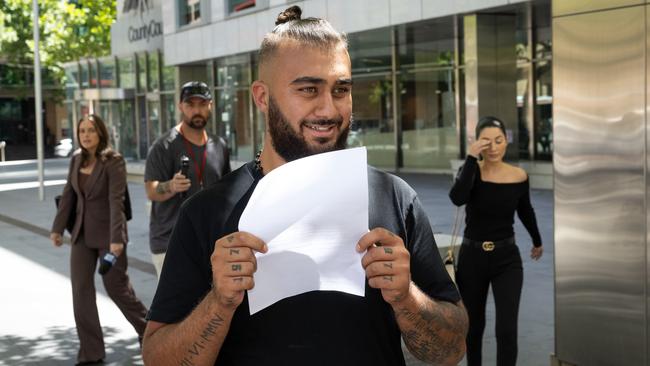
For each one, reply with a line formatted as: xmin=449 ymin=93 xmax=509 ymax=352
xmin=162 ymin=0 xmax=526 ymax=65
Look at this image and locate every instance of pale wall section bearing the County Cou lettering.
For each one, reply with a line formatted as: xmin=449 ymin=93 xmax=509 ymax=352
xmin=111 ymin=0 xmax=163 ymax=56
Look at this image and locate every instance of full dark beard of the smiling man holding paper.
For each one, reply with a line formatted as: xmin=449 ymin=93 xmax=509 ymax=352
xmin=269 ymin=97 xmax=351 ymax=162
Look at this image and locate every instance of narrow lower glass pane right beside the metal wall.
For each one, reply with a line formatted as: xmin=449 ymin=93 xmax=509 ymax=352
xmin=534 ymin=61 xmax=553 ymax=160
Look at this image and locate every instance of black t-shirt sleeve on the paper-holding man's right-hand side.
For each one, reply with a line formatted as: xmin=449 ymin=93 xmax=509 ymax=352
xmin=406 ymin=197 xmax=460 ymax=303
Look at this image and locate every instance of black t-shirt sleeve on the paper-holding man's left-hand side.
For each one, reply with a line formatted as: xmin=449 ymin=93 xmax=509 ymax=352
xmin=147 ymin=205 xmax=212 ymax=324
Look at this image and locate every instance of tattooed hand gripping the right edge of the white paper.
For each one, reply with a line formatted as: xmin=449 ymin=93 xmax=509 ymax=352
xmin=357 ymin=228 xmax=411 ymax=305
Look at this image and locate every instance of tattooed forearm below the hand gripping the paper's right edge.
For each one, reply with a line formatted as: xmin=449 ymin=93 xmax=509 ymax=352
xmin=395 ymin=290 xmax=467 ymax=364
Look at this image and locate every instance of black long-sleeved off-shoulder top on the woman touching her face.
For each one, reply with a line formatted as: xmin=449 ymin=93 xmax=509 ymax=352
xmin=449 ymin=155 xmax=542 ymax=247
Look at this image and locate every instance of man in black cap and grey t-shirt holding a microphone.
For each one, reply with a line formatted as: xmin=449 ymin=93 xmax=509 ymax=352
xmin=144 ymin=81 xmax=230 ymax=277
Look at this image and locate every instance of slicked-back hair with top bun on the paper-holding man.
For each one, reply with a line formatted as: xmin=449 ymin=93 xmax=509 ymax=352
xmin=259 ymin=5 xmax=348 ymax=65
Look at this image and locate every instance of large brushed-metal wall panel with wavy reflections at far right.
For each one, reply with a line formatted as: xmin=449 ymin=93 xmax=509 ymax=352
xmin=553 ymin=5 xmax=647 ymax=366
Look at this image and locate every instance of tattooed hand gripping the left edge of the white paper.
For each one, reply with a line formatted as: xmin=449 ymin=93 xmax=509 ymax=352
xmin=210 ymin=231 xmax=268 ymax=309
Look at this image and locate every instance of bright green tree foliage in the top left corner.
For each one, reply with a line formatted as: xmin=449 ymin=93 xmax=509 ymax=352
xmin=0 ymin=0 xmax=116 ymax=86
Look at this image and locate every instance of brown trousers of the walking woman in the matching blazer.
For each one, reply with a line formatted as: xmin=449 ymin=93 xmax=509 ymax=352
xmin=70 ymin=239 xmax=147 ymax=362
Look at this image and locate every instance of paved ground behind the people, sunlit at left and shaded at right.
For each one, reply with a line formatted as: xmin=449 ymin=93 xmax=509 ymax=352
xmin=0 ymin=159 xmax=554 ymax=366
